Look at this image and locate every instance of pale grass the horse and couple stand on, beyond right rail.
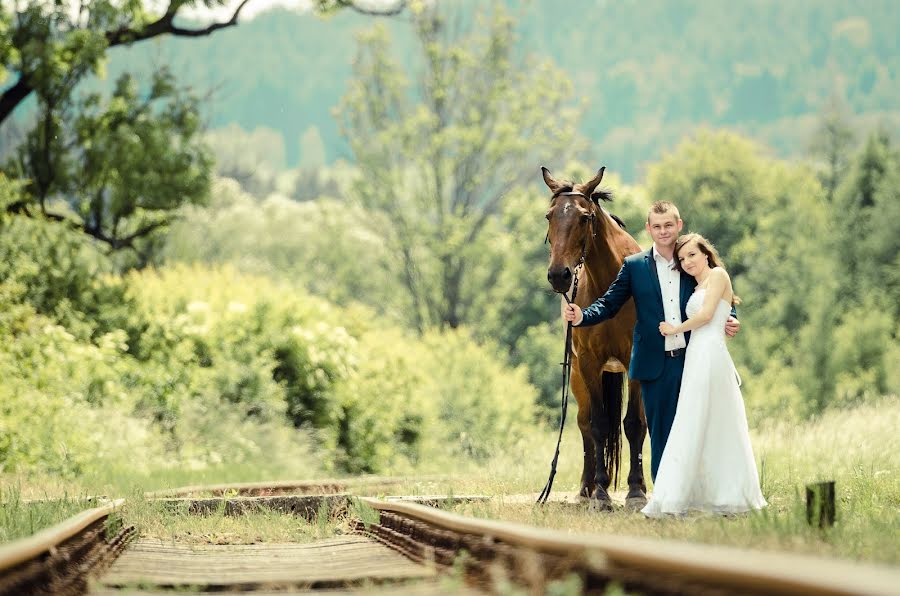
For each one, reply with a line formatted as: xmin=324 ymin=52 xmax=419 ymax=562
xmin=390 ymin=398 xmax=900 ymax=565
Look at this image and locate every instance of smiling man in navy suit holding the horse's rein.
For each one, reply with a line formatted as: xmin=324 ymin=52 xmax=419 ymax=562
xmin=563 ymin=201 xmax=740 ymax=482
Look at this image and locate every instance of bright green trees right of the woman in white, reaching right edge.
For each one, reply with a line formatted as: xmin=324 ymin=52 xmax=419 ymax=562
xmin=649 ymin=130 xmax=900 ymax=420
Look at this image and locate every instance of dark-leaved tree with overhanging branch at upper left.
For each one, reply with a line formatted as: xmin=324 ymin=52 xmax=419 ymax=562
xmin=0 ymin=0 xmax=405 ymax=256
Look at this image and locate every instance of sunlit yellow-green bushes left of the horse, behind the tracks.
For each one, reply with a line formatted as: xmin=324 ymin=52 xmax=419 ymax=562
xmin=0 ymin=186 xmax=534 ymax=477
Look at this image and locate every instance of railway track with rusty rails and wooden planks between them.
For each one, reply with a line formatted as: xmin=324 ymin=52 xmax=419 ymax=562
xmin=0 ymin=479 xmax=900 ymax=595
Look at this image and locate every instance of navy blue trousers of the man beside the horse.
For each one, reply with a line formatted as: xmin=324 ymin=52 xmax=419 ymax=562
xmin=641 ymin=350 xmax=684 ymax=482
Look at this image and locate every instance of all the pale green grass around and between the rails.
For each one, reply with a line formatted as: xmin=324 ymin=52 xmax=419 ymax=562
xmin=0 ymin=397 xmax=900 ymax=565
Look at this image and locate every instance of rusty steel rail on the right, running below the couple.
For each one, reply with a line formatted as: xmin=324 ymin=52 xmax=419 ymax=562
xmin=359 ymin=497 xmax=900 ymax=595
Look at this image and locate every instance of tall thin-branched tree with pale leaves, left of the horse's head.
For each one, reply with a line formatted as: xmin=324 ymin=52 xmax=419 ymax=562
xmin=337 ymin=5 xmax=580 ymax=328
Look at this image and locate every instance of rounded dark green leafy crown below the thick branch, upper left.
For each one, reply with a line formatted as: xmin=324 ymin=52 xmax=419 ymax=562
xmin=7 ymin=69 xmax=212 ymax=264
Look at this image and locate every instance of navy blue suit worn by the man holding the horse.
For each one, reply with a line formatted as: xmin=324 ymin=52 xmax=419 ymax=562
xmin=578 ymin=249 xmax=735 ymax=481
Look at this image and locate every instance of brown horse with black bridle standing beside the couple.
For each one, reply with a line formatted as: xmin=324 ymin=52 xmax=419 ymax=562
xmin=541 ymin=167 xmax=647 ymax=509
